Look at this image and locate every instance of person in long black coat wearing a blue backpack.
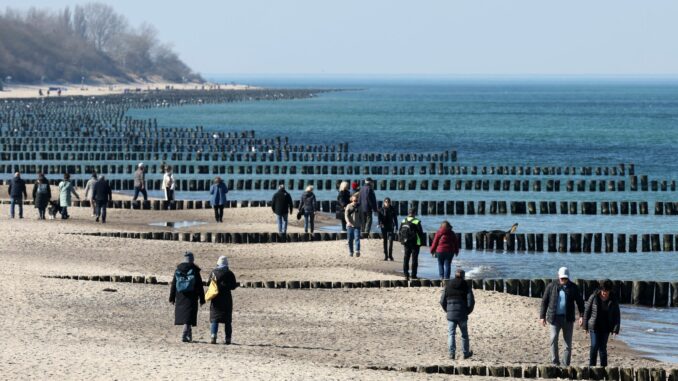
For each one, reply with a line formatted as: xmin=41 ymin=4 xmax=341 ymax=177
xmin=169 ymin=251 xmax=205 ymax=343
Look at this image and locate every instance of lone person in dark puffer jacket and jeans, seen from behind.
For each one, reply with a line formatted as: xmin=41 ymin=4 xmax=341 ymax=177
xmin=440 ymin=269 xmax=476 ymax=360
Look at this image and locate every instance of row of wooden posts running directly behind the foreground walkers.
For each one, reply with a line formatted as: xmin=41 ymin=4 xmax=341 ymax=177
xmin=46 ymin=275 xmax=678 ymax=307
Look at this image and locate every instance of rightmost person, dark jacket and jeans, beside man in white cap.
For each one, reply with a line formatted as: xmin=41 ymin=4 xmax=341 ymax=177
xmin=584 ymin=279 xmax=621 ymax=366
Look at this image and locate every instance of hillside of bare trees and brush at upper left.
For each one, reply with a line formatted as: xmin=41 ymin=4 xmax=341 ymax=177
xmin=0 ymin=3 xmax=202 ymax=86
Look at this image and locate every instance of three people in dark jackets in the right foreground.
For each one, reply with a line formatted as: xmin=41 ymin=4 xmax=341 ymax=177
xmin=440 ymin=267 xmax=620 ymax=367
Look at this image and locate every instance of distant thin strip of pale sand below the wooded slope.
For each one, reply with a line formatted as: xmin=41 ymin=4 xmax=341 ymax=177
xmin=0 ymin=82 xmax=256 ymax=99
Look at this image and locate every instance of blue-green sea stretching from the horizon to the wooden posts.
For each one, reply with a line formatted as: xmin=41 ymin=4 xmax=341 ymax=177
xmin=129 ymin=76 xmax=678 ymax=362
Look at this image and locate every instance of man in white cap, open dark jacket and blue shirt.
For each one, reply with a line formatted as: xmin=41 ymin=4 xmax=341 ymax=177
xmin=539 ymin=267 xmax=584 ymax=366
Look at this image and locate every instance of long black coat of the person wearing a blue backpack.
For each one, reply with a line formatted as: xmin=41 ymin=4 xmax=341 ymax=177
xmin=170 ymin=263 xmax=205 ymax=327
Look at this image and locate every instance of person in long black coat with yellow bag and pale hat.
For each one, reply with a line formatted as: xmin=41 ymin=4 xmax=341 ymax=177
xmin=208 ymin=255 xmax=238 ymax=345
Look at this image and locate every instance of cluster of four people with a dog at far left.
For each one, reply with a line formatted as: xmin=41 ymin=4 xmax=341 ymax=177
xmin=8 ymin=172 xmax=112 ymax=223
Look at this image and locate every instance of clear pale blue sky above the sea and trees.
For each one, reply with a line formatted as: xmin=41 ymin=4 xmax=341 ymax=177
xmin=5 ymin=0 xmax=678 ymax=77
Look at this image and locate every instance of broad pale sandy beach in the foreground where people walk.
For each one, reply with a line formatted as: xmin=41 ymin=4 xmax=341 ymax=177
xmin=0 ymin=205 xmax=670 ymax=380
